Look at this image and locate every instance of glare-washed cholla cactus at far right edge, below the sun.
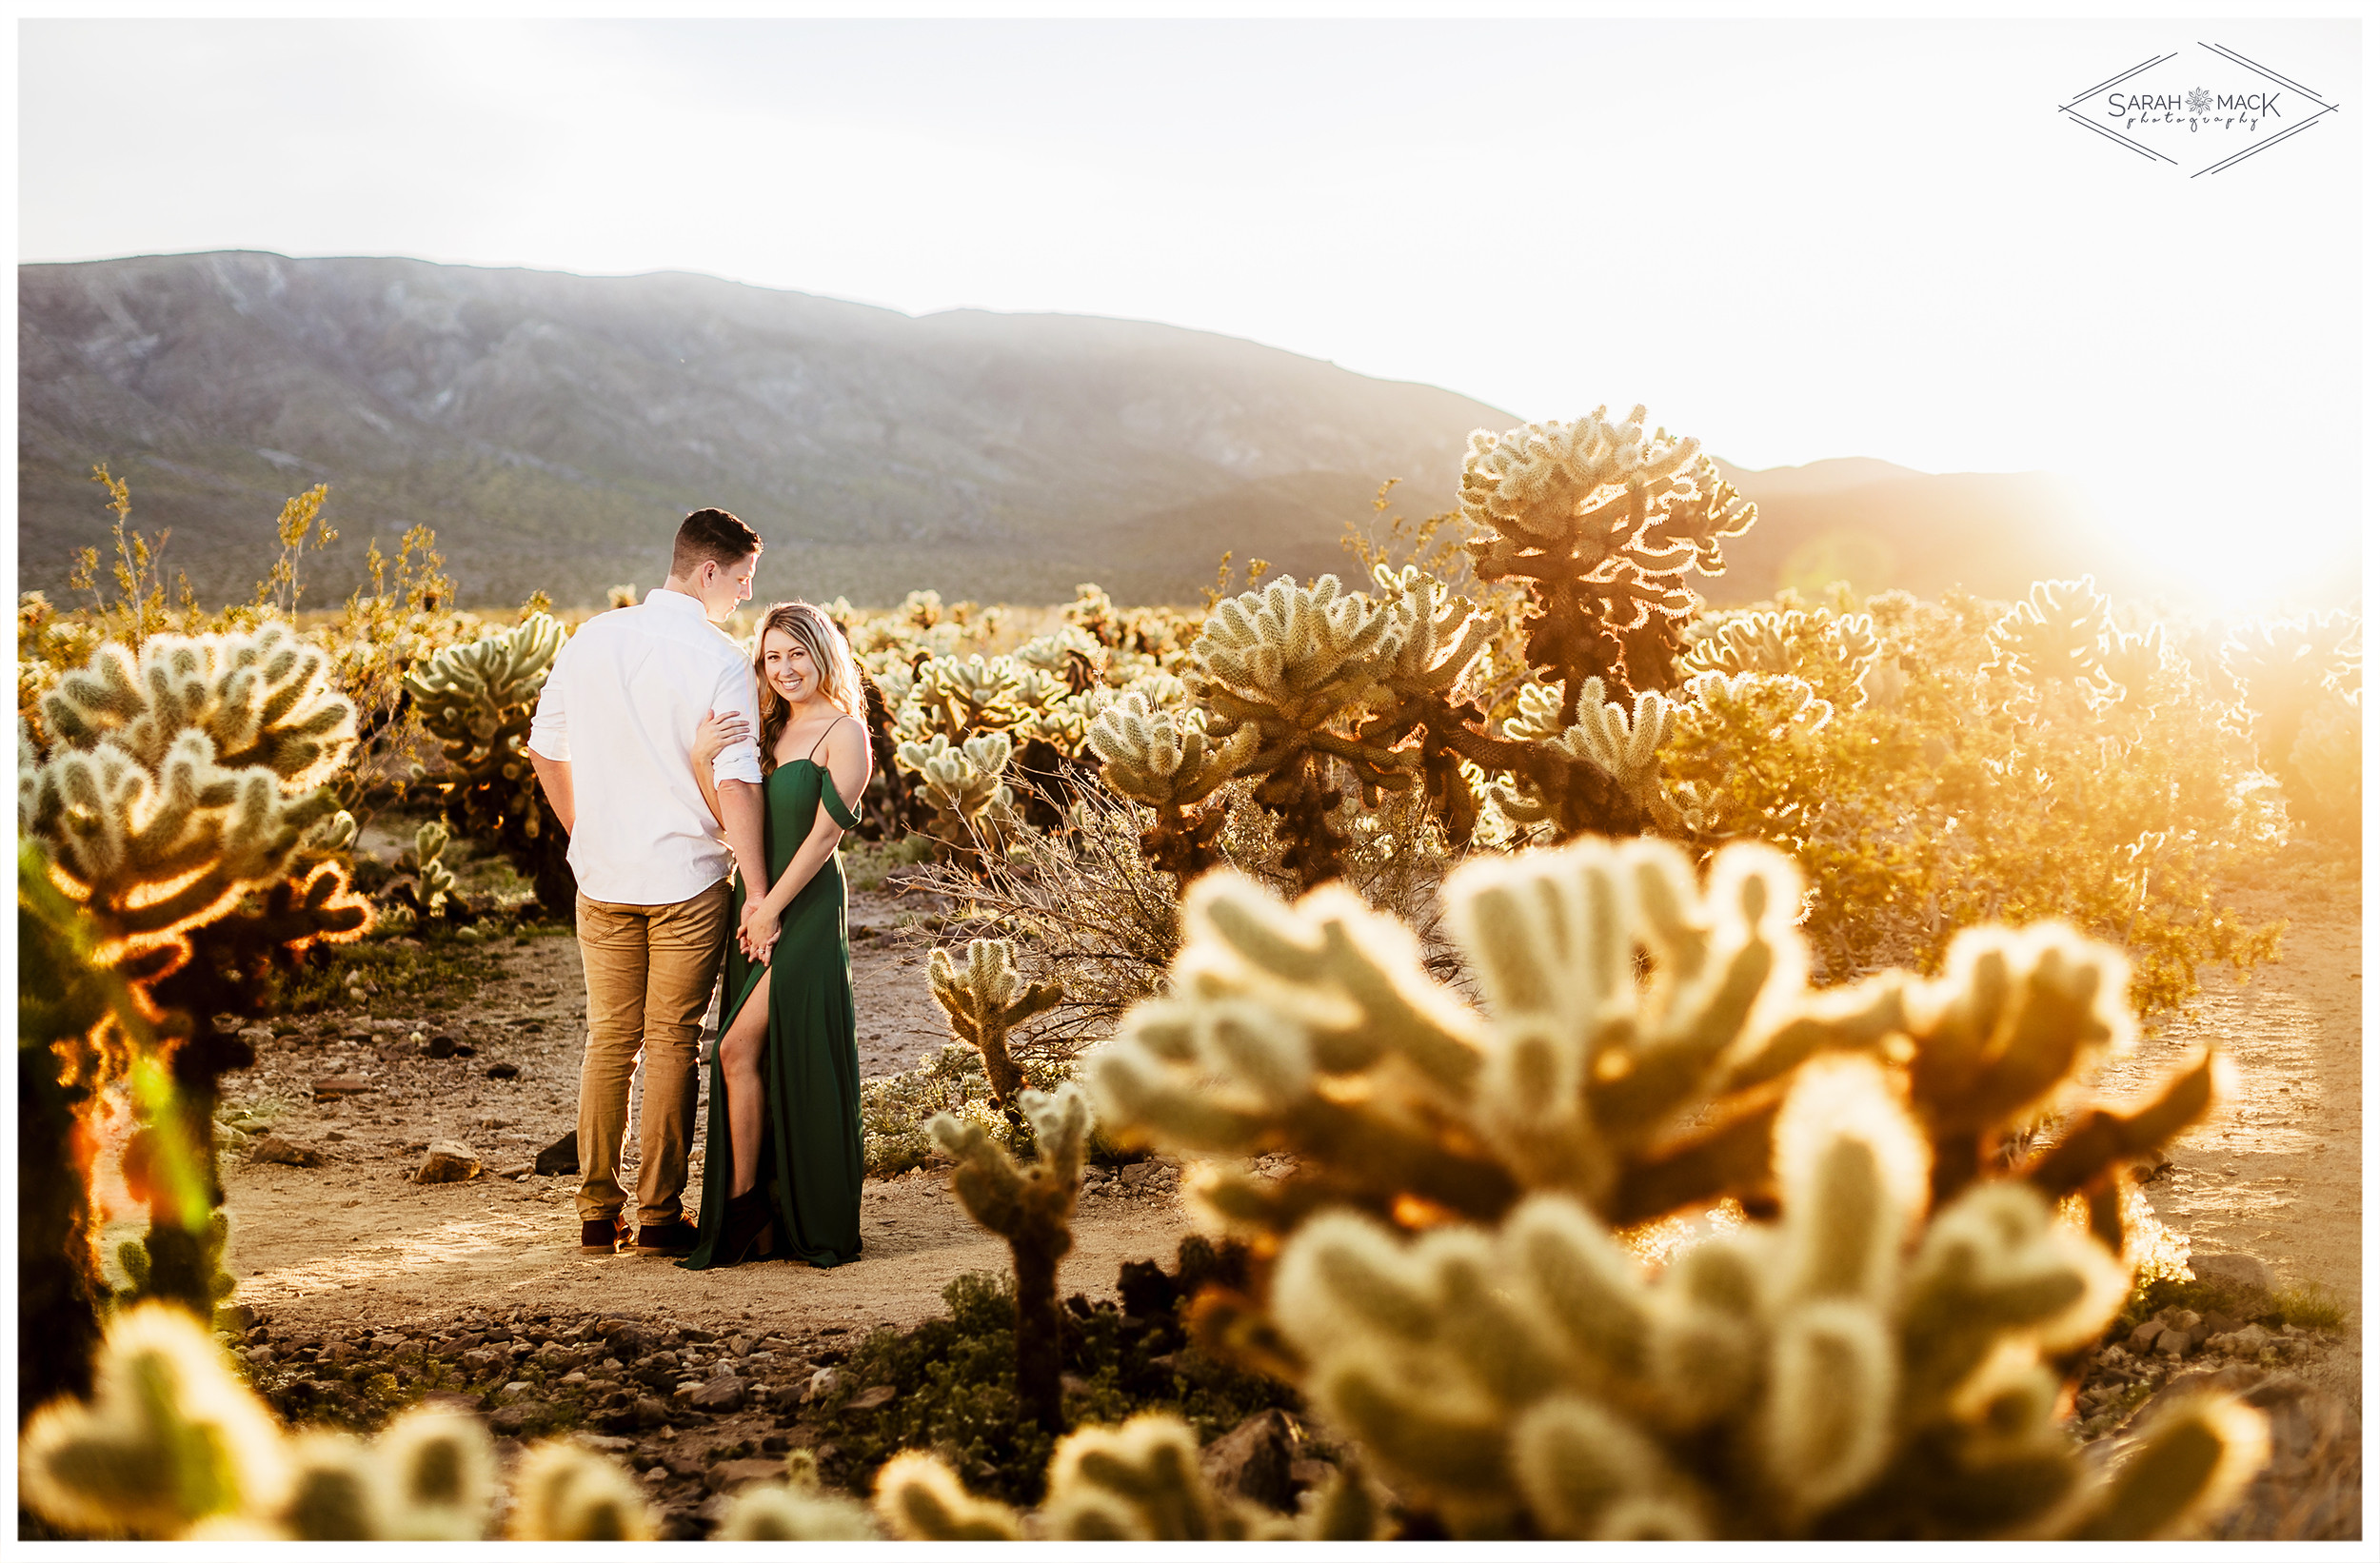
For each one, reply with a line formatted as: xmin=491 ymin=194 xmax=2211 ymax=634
xmin=2223 ymin=611 xmax=2364 ymax=833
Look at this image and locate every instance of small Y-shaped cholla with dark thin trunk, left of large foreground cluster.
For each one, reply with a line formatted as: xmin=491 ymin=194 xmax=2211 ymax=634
xmin=926 ymin=1085 xmax=1090 ymax=1433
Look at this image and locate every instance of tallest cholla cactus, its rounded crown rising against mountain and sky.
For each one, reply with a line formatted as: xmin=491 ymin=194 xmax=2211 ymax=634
xmin=1461 ymin=406 xmax=1755 ymax=713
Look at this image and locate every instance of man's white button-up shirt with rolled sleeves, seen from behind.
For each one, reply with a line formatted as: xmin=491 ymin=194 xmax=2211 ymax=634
xmin=528 ymin=587 xmax=760 ymax=906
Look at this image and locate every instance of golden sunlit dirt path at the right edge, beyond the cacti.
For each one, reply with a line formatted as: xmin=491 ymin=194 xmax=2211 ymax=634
xmin=2104 ymin=880 xmax=2364 ymax=1333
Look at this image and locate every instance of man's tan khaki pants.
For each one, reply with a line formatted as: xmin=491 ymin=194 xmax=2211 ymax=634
xmin=579 ymin=880 xmax=733 ymax=1225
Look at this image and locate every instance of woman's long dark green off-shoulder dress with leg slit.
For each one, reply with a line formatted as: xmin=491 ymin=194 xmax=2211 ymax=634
xmin=679 ymin=759 xmax=864 ymax=1271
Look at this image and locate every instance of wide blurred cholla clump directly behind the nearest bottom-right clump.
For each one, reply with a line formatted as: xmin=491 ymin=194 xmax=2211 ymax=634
xmin=1090 ymin=840 xmax=2216 ymax=1249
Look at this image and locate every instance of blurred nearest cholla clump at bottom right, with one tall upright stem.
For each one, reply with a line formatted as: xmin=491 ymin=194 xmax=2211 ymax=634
xmin=1274 ymin=1058 xmax=2266 ymax=1539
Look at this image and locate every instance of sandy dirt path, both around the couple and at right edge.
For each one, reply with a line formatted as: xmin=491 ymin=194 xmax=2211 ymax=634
xmin=103 ymin=870 xmax=2364 ymax=1330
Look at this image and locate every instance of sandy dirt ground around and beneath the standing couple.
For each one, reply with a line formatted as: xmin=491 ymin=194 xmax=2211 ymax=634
xmin=125 ymin=895 xmax=1190 ymax=1330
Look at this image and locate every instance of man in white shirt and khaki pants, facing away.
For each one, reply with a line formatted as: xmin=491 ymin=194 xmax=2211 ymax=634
xmin=528 ymin=509 xmax=769 ymax=1254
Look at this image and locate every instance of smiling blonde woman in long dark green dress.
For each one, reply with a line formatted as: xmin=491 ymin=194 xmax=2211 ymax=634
xmin=679 ymin=602 xmax=871 ymax=1271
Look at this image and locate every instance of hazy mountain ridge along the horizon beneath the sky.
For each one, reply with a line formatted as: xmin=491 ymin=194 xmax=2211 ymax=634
xmin=17 ymin=249 xmax=2209 ymax=604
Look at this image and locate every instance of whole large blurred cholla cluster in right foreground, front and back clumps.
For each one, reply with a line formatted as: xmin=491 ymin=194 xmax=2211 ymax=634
xmin=1090 ymin=840 xmax=2256 ymax=1537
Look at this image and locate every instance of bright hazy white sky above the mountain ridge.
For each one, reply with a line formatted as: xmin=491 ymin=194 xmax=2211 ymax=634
xmin=19 ymin=21 xmax=2364 ymax=600
